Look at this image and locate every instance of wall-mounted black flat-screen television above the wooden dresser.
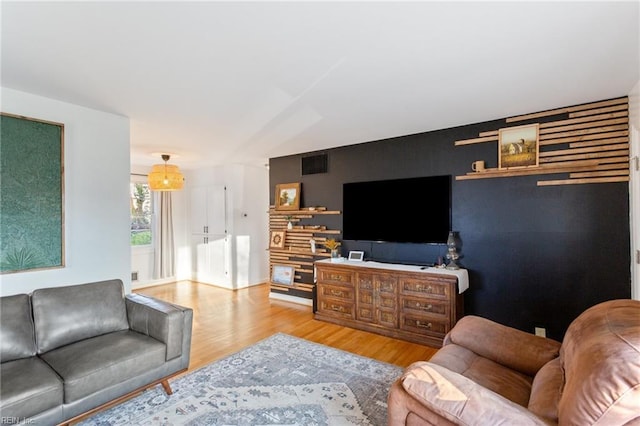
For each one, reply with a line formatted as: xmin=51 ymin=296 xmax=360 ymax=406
xmin=342 ymin=175 xmax=451 ymax=243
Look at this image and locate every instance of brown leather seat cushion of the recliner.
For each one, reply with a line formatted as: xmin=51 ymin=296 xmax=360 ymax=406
xmin=429 ymin=343 xmax=533 ymax=407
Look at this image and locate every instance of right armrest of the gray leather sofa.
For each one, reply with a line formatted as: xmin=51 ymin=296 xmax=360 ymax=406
xmin=126 ymin=294 xmax=193 ymax=361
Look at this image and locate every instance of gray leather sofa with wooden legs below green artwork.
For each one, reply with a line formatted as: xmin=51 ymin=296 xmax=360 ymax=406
xmin=0 ymin=280 xmax=193 ymax=425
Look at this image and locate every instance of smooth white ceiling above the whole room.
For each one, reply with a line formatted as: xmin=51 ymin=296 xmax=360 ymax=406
xmin=0 ymin=1 xmax=640 ymax=169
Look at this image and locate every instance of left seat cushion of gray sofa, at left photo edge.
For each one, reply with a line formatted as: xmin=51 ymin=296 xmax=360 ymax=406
xmin=0 ymin=357 xmax=64 ymax=419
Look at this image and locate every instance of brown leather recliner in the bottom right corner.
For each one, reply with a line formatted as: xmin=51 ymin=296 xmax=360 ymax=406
xmin=388 ymin=300 xmax=640 ymax=426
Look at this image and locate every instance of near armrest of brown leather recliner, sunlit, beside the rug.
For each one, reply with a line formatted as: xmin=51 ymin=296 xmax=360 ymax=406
xmin=400 ymin=361 xmax=549 ymax=425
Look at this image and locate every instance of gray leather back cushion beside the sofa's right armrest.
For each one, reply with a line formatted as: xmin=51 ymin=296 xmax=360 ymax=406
xmin=31 ymin=280 xmax=129 ymax=354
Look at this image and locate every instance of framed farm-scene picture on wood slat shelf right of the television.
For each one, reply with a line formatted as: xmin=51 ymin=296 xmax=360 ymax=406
xmin=498 ymin=124 xmax=540 ymax=169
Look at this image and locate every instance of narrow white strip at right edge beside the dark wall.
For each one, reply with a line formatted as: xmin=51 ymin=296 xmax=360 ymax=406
xmin=629 ymin=81 xmax=640 ymax=300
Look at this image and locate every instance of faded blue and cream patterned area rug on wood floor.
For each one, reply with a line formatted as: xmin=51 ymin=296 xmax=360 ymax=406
xmin=80 ymin=333 xmax=402 ymax=426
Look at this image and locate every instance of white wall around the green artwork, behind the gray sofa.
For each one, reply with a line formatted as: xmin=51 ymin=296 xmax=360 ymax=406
xmin=0 ymin=88 xmax=131 ymax=295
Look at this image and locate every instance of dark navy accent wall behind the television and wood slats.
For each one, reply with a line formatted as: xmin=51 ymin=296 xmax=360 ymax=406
xmin=269 ymin=111 xmax=631 ymax=340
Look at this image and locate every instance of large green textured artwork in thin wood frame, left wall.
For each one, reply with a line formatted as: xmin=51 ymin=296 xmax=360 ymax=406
xmin=0 ymin=113 xmax=64 ymax=274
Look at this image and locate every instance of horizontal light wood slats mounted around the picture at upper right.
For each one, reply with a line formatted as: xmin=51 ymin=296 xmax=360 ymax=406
xmin=454 ymin=97 xmax=629 ymax=186
